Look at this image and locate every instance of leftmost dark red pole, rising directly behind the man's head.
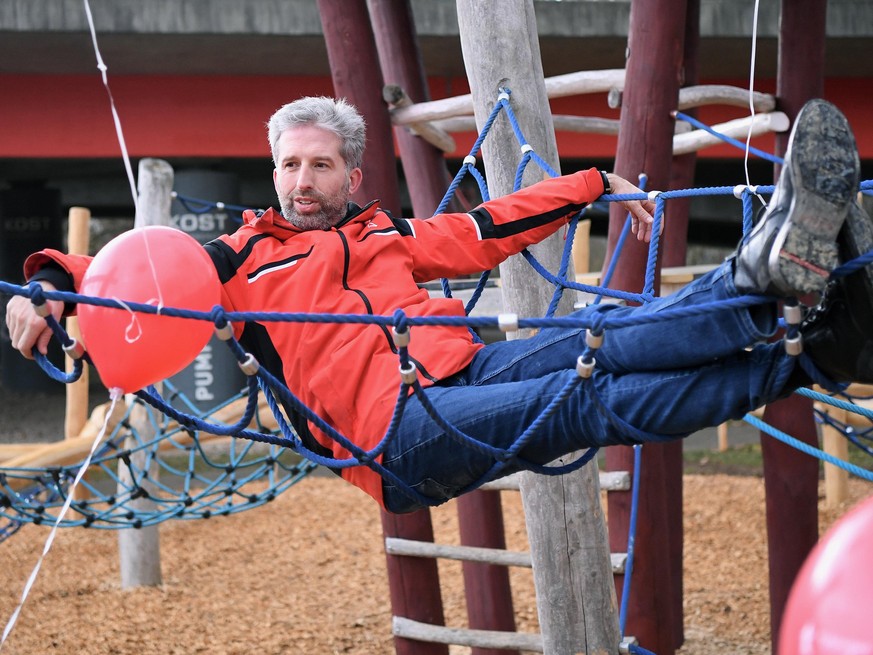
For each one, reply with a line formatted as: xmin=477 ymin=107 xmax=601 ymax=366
xmin=318 ymin=0 xmax=448 ymax=655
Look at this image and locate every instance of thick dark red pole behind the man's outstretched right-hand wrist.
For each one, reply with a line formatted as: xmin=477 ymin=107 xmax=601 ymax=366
xmin=606 ymin=0 xmax=686 ymax=655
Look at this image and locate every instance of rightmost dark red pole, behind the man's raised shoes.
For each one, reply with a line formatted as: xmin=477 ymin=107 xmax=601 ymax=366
xmin=761 ymin=0 xmax=827 ymax=652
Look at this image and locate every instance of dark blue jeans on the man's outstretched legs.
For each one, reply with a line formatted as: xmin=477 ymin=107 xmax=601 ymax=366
xmin=382 ymin=261 xmax=791 ymax=513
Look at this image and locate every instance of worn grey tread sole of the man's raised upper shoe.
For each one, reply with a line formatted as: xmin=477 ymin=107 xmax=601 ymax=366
xmin=768 ymin=100 xmax=860 ymax=295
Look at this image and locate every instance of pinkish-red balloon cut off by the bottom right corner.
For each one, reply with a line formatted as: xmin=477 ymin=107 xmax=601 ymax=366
xmin=779 ymin=497 xmax=873 ymax=655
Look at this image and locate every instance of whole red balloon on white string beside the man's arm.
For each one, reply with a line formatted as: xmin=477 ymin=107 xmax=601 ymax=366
xmin=78 ymin=226 xmax=220 ymax=393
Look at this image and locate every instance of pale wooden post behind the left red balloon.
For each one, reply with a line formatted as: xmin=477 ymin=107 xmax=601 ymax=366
xmin=118 ymin=159 xmax=173 ymax=589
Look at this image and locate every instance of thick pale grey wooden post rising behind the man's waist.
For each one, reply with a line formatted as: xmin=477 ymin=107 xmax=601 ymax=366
xmin=457 ymin=0 xmax=619 ymax=653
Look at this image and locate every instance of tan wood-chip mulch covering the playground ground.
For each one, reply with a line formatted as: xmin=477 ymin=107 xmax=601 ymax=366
xmin=0 ymin=468 xmax=871 ymax=655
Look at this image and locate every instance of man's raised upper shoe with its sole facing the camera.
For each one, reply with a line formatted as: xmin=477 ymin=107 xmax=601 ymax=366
xmin=735 ymin=100 xmax=860 ymax=297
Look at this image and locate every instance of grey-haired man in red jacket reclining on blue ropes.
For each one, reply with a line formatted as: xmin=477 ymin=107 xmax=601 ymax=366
xmin=7 ymin=98 xmax=873 ymax=512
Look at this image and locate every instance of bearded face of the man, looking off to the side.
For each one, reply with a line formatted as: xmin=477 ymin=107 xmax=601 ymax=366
xmin=273 ymin=125 xmax=361 ymax=230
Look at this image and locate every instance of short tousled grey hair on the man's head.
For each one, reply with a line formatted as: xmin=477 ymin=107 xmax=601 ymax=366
xmin=267 ymin=96 xmax=367 ymax=171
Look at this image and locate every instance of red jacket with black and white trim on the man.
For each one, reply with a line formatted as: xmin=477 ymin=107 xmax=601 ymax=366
xmin=25 ymin=169 xmax=603 ymax=503
